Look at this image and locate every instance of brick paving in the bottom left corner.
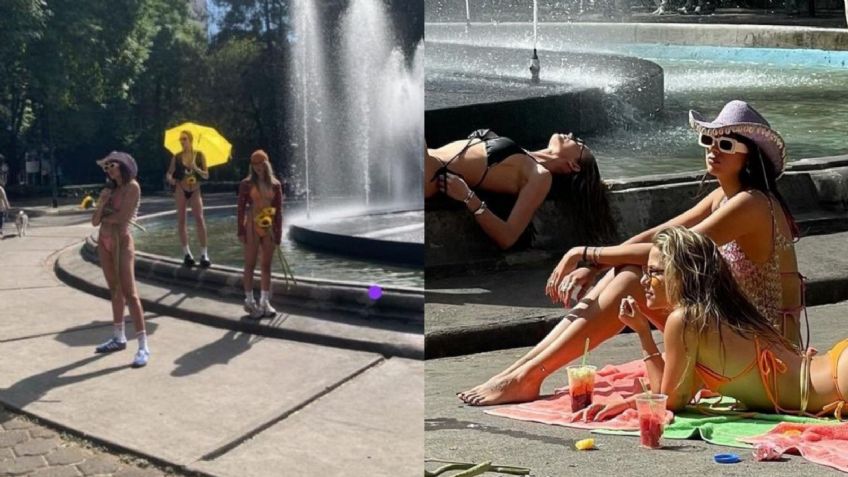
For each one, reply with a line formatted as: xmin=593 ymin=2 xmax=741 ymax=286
xmin=0 ymin=406 xmax=187 ymax=477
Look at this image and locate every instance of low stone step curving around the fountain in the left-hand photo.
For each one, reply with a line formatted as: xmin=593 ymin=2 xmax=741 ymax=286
xmin=54 ymin=242 xmax=424 ymax=359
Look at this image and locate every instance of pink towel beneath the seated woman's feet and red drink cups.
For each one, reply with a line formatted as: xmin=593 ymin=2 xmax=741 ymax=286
xmin=485 ymin=359 xmax=674 ymax=431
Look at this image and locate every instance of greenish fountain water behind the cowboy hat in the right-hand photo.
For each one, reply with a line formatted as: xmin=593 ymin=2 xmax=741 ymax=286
xmin=426 ymin=24 xmax=848 ymax=178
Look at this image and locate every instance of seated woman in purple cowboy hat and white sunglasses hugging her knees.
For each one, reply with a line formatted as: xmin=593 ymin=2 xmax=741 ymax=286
xmin=458 ymin=101 xmax=803 ymax=405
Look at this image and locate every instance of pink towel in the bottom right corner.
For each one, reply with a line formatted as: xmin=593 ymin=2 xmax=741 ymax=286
xmin=739 ymin=422 xmax=848 ymax=472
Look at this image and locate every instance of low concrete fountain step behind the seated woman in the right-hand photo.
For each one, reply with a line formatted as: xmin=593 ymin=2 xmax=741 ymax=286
xmin=424 ymin=228 xmax=848 ymax=359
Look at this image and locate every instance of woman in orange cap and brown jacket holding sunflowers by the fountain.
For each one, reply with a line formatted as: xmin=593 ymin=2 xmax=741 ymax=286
xmin=238 ymin=150 xmax=283 ymax=318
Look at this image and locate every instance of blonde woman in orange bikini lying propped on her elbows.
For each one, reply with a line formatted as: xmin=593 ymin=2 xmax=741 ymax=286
xmin=581 ymin=227 xmax=848 ymax=420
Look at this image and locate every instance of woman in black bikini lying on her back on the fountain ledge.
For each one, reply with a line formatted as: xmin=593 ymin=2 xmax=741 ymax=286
xmin=424 ymin=129 xmax=612 ymax=250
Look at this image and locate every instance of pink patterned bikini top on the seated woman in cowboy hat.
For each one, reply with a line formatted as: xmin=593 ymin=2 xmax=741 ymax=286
xmin=719 ymin=191 xmax=797 ymax=329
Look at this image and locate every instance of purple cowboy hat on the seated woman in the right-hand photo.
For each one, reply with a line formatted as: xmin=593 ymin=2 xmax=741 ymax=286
xmin=689 ymin=100 xmax=786 ymax=177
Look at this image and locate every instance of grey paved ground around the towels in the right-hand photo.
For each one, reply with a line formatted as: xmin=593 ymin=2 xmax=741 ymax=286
xmin=425 ymin=302 xmax=848 ymax=477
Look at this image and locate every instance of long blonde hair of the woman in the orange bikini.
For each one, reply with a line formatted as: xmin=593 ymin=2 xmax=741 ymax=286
xmin=653 ymin=226 xmax=793 ymax=349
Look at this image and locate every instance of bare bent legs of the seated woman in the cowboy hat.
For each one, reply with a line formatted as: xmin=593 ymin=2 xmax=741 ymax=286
xmin=460 ymin=267 xmax=663 ymax=405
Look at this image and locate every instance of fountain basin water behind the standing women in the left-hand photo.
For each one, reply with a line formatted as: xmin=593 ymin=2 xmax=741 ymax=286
xmin=135 ymin=211 xmax=424 ymax=288
